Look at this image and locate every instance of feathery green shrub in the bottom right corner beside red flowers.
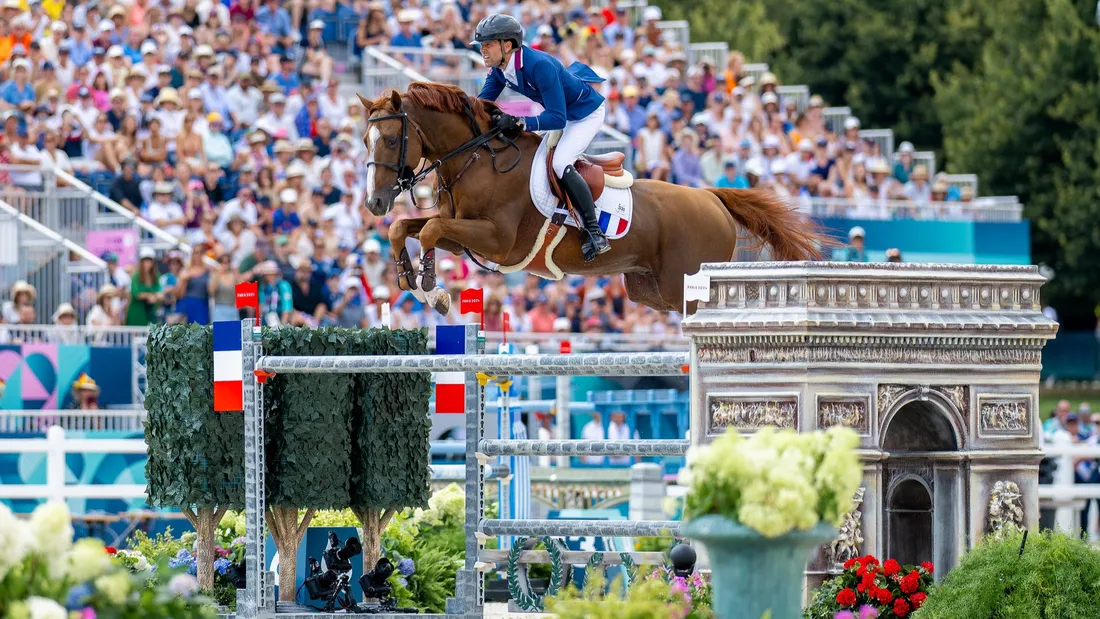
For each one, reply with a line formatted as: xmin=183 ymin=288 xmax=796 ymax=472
xmin=914 ymin=531 xmax=1100 ymax=619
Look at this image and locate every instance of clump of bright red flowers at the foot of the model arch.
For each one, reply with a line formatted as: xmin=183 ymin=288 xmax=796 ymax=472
xmin=807 ymin=555 xmax=933 ymax=619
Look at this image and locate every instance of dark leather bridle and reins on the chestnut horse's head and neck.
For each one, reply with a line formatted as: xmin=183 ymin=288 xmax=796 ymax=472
xmin=366 ymin=93 xmax=523 ymax=209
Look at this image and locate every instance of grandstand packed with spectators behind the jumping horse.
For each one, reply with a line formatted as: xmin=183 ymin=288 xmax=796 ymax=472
xmin=0 ymin=0 xmax=1029 ymax=345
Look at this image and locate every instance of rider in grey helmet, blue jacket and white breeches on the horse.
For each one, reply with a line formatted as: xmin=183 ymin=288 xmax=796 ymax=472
xmin=473 ymin=13 xmax=612 ymax=262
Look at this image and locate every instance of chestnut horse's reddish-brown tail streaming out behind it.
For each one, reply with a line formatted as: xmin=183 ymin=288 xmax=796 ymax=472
xmin=707 ymin=188 xmax=835 ymax=261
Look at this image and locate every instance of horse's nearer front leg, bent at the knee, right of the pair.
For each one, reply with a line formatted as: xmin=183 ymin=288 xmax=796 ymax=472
xmin=419 ymin=218 xmax=516 ymax=316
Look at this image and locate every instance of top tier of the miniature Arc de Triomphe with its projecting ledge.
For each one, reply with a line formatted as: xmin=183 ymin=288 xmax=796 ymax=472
xmin=683 ymin=263 xmax=1057 ymax=340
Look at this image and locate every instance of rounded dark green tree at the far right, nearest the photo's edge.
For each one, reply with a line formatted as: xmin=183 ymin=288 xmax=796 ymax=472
xmin=935 ymin=0 xmax=1100 ymax=318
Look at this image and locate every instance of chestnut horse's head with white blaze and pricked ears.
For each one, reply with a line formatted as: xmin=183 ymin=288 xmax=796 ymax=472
xmin=359 ymin=90 xmax=425 ymax=217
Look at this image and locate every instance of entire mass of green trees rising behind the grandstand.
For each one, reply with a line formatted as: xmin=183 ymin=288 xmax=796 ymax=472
xmin=660 ymin=0 xmax=1100 ymax=318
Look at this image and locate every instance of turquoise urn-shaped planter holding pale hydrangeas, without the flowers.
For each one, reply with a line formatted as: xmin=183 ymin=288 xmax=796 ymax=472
xmin=680 ymin=516 xmax=836 ymax=619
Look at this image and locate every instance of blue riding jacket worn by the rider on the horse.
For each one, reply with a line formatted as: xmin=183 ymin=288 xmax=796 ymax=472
xmin=477 ymin=45 xmax=604 ymax=131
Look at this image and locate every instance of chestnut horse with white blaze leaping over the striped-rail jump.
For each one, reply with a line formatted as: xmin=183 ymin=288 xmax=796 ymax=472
xmin=360 ymin=82 xmax=828 ymax=314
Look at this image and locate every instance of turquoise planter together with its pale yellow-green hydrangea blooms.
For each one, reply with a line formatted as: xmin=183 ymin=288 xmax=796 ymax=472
xmin=681 ymin=428 xmax=862 ymax=619
